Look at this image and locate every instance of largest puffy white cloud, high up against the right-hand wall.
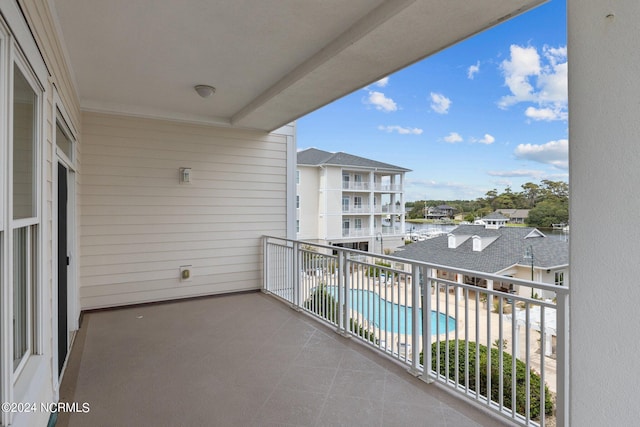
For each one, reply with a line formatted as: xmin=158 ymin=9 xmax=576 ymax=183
xmin=498 ymin=45 xmax=568 ymax=121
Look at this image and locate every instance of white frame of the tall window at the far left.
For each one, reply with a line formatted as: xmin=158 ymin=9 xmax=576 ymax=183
xmin=0 ymin=4 xmax=50 ymax=425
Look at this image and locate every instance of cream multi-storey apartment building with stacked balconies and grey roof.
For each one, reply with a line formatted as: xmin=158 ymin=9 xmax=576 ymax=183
xmin=296 ymin=148 xmax=410 ymax=253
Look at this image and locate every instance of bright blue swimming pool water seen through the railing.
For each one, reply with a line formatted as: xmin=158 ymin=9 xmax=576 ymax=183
xmin=327 ymin=286 xmax=456 ymax=335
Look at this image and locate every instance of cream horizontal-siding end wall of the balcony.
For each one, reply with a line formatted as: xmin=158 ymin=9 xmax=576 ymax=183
xmin=80 ymin=113 xmax=288 ymax=308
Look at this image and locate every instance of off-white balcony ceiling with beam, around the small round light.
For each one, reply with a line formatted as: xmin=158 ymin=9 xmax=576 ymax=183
xmin=50 ymin=0 xmax=544 ymax=130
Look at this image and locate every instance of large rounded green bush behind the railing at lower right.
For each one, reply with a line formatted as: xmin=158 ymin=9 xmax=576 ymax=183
xmin=420 ymin=340 xmax=553 ymax=419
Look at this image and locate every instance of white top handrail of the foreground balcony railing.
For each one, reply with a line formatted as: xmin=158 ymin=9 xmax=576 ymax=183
xmin=264 ymin=236 xmax=569 ymax=295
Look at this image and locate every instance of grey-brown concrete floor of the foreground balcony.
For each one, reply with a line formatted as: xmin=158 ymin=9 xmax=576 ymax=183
xmin=57 ymin=292 xmax=510 ymax=427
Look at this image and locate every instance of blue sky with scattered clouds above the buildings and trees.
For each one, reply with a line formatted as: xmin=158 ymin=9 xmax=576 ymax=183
xmin=297 ymin=0 xmax=569 ymax=201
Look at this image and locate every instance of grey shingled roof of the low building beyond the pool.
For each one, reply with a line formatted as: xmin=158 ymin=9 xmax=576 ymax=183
xmin=393 ymin=225 xmax=569 ymax=273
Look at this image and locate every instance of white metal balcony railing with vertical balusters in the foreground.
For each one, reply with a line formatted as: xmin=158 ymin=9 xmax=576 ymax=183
xmin=263 ymin=237 xmax=569 ymax=426
